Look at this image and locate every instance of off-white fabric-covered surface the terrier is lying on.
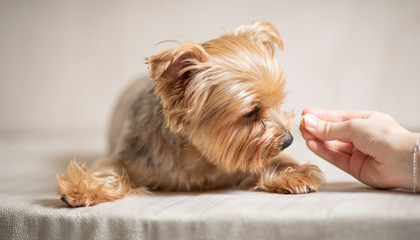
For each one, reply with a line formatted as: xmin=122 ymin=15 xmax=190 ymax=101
xmin=0 ymin=131 xmax=420 ymax=239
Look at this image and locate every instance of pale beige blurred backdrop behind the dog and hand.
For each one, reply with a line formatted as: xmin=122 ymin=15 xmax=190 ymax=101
xmin=0 ymin=0 xmax=420 ymax=136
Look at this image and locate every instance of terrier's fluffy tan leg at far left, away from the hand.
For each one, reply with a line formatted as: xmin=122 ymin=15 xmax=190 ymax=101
xmin=57 ymin=158 xmax=147 ymax=207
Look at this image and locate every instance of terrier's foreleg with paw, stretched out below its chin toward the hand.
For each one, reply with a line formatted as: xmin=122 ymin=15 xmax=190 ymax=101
xmin=241 ymin=155 xmax=323 ymax=194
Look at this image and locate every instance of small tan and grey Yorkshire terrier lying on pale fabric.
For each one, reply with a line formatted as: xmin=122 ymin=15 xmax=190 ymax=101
xmin=57 ymin=21 xmax=323 ymax=207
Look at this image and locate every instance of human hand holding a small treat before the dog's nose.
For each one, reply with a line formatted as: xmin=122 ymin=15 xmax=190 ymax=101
xmin=300 ymin=108 xmax=420 ymax=189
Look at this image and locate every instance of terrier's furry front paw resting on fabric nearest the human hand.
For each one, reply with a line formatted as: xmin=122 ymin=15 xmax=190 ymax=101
xmin=257 ymin=164 xmax=324 ymax=194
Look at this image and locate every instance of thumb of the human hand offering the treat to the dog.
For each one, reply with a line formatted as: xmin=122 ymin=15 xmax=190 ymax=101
xmin=302 ymin=113 xmax=355 ymax=142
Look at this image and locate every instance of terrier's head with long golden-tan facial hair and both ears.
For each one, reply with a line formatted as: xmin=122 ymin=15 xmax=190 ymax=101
xmin=148 ymin=22 xmax=291 ymax=172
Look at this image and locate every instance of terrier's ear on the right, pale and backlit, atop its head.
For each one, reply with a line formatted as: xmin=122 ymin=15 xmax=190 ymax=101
xmin=235 ymin=21 xmax=283 ymax=56
